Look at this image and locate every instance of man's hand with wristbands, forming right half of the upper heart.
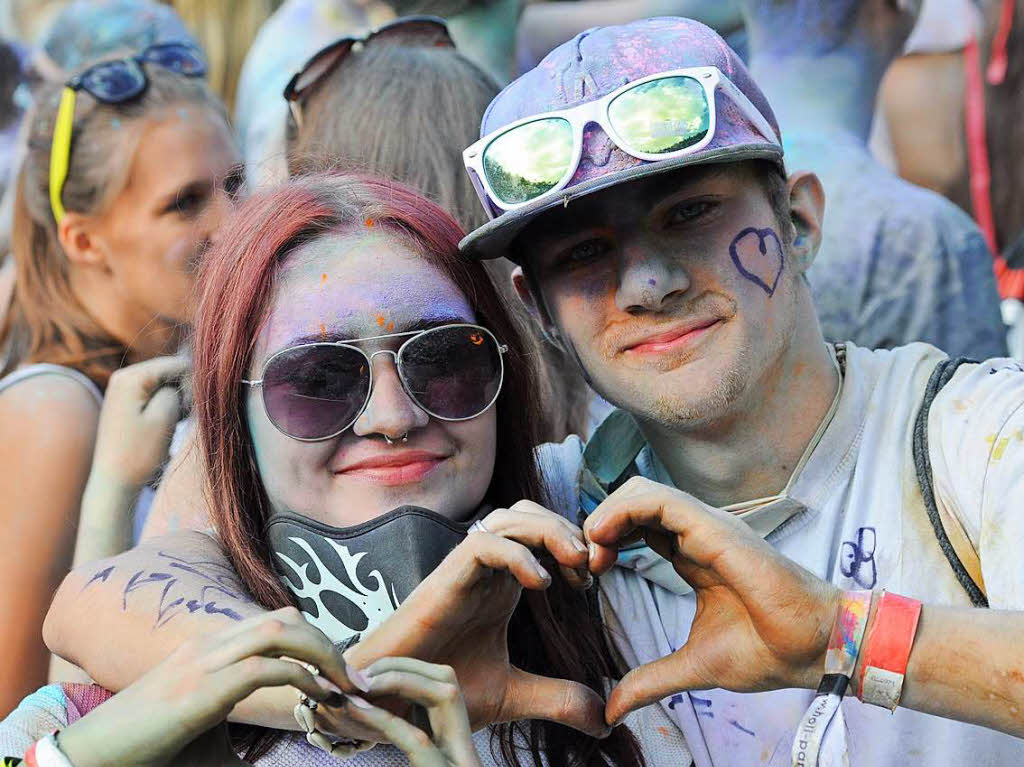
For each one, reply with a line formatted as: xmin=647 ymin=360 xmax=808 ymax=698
xmin=584 ymin=477 xmax=840 ymax=722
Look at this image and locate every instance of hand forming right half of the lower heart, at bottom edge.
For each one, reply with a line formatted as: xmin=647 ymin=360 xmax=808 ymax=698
xmin=345 ymin=657 xmax=480 ymax=767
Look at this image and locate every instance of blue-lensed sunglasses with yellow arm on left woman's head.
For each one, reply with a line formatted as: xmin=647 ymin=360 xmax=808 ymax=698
xmin=50 ymin=42 xmax=206 ymax=223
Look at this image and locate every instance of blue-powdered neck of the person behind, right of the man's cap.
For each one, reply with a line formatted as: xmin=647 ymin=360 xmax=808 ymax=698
xmin=750 ymin=44 xmax=890 ymax=144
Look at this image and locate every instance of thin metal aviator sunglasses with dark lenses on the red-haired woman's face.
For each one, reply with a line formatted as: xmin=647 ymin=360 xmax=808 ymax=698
xmin=242 ymin=324 xmax=508 ymax=442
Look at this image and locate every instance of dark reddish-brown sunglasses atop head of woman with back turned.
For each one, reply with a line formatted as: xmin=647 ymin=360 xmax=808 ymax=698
xmin=284 ymin=15 xmax=455 ymax=128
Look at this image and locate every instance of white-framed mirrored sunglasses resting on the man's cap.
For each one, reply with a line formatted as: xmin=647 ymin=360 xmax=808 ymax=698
xmin=463 ymin=67 xmax=779 ymax=217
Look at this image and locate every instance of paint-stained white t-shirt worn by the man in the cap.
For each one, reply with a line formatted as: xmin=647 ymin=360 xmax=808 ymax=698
xmin=539 ymin=343 xmax=1024 ymax=767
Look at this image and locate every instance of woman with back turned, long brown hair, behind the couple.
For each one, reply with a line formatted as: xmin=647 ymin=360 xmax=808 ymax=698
xmin=144 ymin=18 xmax=591 ymax=538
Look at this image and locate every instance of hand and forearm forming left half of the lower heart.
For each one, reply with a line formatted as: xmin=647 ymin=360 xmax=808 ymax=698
xmin=59 ymin=607 xmax=362 ymax=767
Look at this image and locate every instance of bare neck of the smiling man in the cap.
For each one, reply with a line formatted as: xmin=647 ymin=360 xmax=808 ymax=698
xmin=641 ymin=299 xmax=840 ymax=506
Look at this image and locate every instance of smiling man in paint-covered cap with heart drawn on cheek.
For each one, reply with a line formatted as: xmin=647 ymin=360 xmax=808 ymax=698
xmin=41 ymin=11 xmax=1024 ymax=767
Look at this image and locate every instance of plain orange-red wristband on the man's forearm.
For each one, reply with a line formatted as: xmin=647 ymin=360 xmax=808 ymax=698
xmin=859 ymin=591 xmax=921 ymax=711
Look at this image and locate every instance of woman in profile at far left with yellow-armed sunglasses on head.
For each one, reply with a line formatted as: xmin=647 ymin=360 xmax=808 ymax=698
xmin=0 ymin=44 xmax=237 ymax=713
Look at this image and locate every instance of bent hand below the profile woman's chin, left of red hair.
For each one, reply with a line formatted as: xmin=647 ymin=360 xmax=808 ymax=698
xmin=90 ymin=356 xmax=191 ymax=489
